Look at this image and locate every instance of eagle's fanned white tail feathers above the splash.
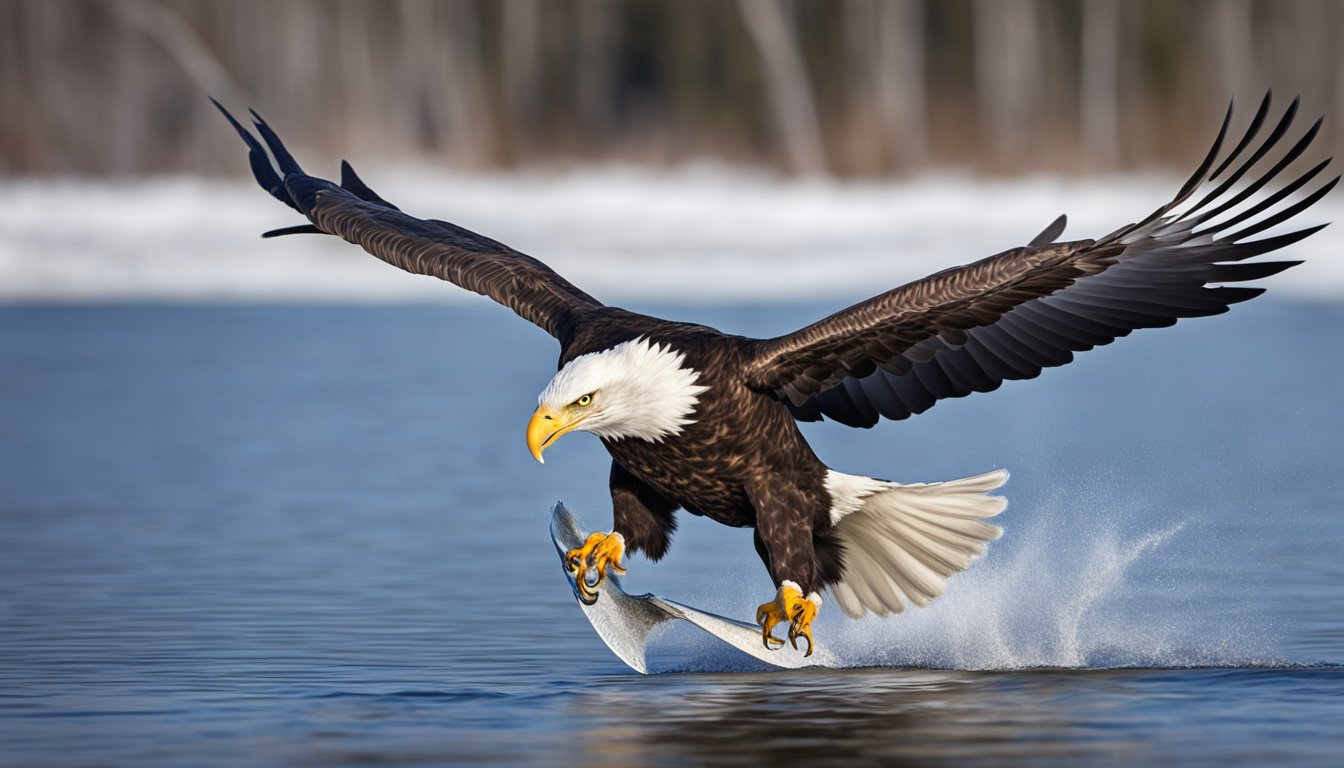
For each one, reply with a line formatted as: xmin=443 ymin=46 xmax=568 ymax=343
xmin=827 ymin=469 xmax=1008 ymax=619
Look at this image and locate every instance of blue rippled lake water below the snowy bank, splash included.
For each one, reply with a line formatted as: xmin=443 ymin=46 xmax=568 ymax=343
xmin=0 ymin=299 xmax=1344 ymax=765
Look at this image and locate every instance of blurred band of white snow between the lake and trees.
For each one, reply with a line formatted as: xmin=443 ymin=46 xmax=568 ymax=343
xmin=0 ymin=167 xmax=1344 ymax=303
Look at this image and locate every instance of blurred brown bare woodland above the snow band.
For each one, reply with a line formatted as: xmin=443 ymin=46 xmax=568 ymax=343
xmin=0 ymin=0 xmax=1344 ymax=178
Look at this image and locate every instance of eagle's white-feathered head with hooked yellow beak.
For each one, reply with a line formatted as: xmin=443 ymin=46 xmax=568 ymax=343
xmin=527 ymin=336 xmax=707 ymax=463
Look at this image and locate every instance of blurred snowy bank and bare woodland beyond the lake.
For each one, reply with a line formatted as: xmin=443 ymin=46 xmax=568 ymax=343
xmin=0 ymin=0 xmax=1344 ymax=301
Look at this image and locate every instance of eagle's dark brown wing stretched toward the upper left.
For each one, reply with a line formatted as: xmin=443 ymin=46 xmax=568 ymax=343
xmin=215 ymin=102 xmax=602 ymax=343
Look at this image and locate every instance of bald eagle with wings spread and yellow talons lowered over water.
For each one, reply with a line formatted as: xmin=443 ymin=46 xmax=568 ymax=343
xmin=216 ymin=94 xmax=1339 ymax=654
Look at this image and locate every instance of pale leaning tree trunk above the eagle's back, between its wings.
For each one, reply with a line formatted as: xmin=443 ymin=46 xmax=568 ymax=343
xmin=738 ymin=0 xmax=827 ymax=174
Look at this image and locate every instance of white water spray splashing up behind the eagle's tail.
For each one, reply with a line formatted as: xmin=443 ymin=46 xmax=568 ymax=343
xmin=824 ymin=489 xmax=1282 ymax=670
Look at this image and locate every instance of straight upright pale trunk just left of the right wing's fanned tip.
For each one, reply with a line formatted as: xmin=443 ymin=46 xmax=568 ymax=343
xmin=1078 ymin=0 xmax=1121 ymax=168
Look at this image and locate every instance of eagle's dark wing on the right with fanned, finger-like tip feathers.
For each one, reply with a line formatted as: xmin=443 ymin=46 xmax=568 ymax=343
xmin=746 ymin=94 xmax=1339 ymax=426
